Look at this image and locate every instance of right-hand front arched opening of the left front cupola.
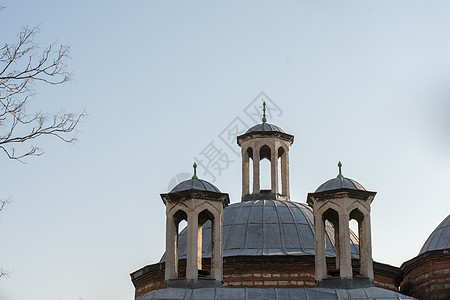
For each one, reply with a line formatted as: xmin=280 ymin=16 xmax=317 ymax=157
xmin=197 ymin=209 xmax=215 ymax=278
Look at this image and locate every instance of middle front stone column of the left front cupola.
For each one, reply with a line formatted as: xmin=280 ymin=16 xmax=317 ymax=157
xmin=186 ymin=212 xmax=198 ymax=280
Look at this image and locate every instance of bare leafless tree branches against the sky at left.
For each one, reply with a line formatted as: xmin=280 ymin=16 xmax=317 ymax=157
xmin=0 ymin=26 xmax=85 ymax=162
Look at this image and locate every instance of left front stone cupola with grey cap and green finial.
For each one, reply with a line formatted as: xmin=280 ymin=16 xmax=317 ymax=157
xmin=161 ymin=163 xmax=230 ymax=288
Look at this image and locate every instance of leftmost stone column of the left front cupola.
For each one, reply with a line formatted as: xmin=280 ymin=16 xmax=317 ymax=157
xmin=164 ymin=214 xmax=178 ymax=281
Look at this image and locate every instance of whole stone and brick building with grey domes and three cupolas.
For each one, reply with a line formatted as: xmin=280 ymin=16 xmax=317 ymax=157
xmin=131 ymin=104 xmax=450 ymax=300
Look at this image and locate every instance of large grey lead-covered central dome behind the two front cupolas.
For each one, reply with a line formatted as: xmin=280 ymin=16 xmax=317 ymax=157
xmin=161 ymin=200 xmax=359 ymax=261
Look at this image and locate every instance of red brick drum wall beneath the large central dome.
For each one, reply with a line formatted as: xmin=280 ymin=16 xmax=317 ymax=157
xmin=132 ymin=256 xmax=401 ymax=298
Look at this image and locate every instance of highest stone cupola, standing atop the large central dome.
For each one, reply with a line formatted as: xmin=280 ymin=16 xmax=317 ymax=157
xmin=237 ymin=102 xmax=294 ymax=201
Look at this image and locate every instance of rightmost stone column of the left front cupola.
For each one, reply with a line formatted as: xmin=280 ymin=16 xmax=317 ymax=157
xmin=211 ymin=214 xmax=223 ymax=281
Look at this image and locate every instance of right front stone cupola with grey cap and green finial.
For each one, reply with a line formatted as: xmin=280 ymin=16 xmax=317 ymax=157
xmin=307 ymin=162 xmax=376 ymax=288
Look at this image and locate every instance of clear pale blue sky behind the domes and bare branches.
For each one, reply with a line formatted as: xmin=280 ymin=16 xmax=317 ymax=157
xmin=0 ymin=0 xmax=450 ymax=300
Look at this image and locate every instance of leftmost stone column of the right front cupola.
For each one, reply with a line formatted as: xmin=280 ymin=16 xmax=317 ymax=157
xmin=314 ymin=214 xmax=327 ymax=281
